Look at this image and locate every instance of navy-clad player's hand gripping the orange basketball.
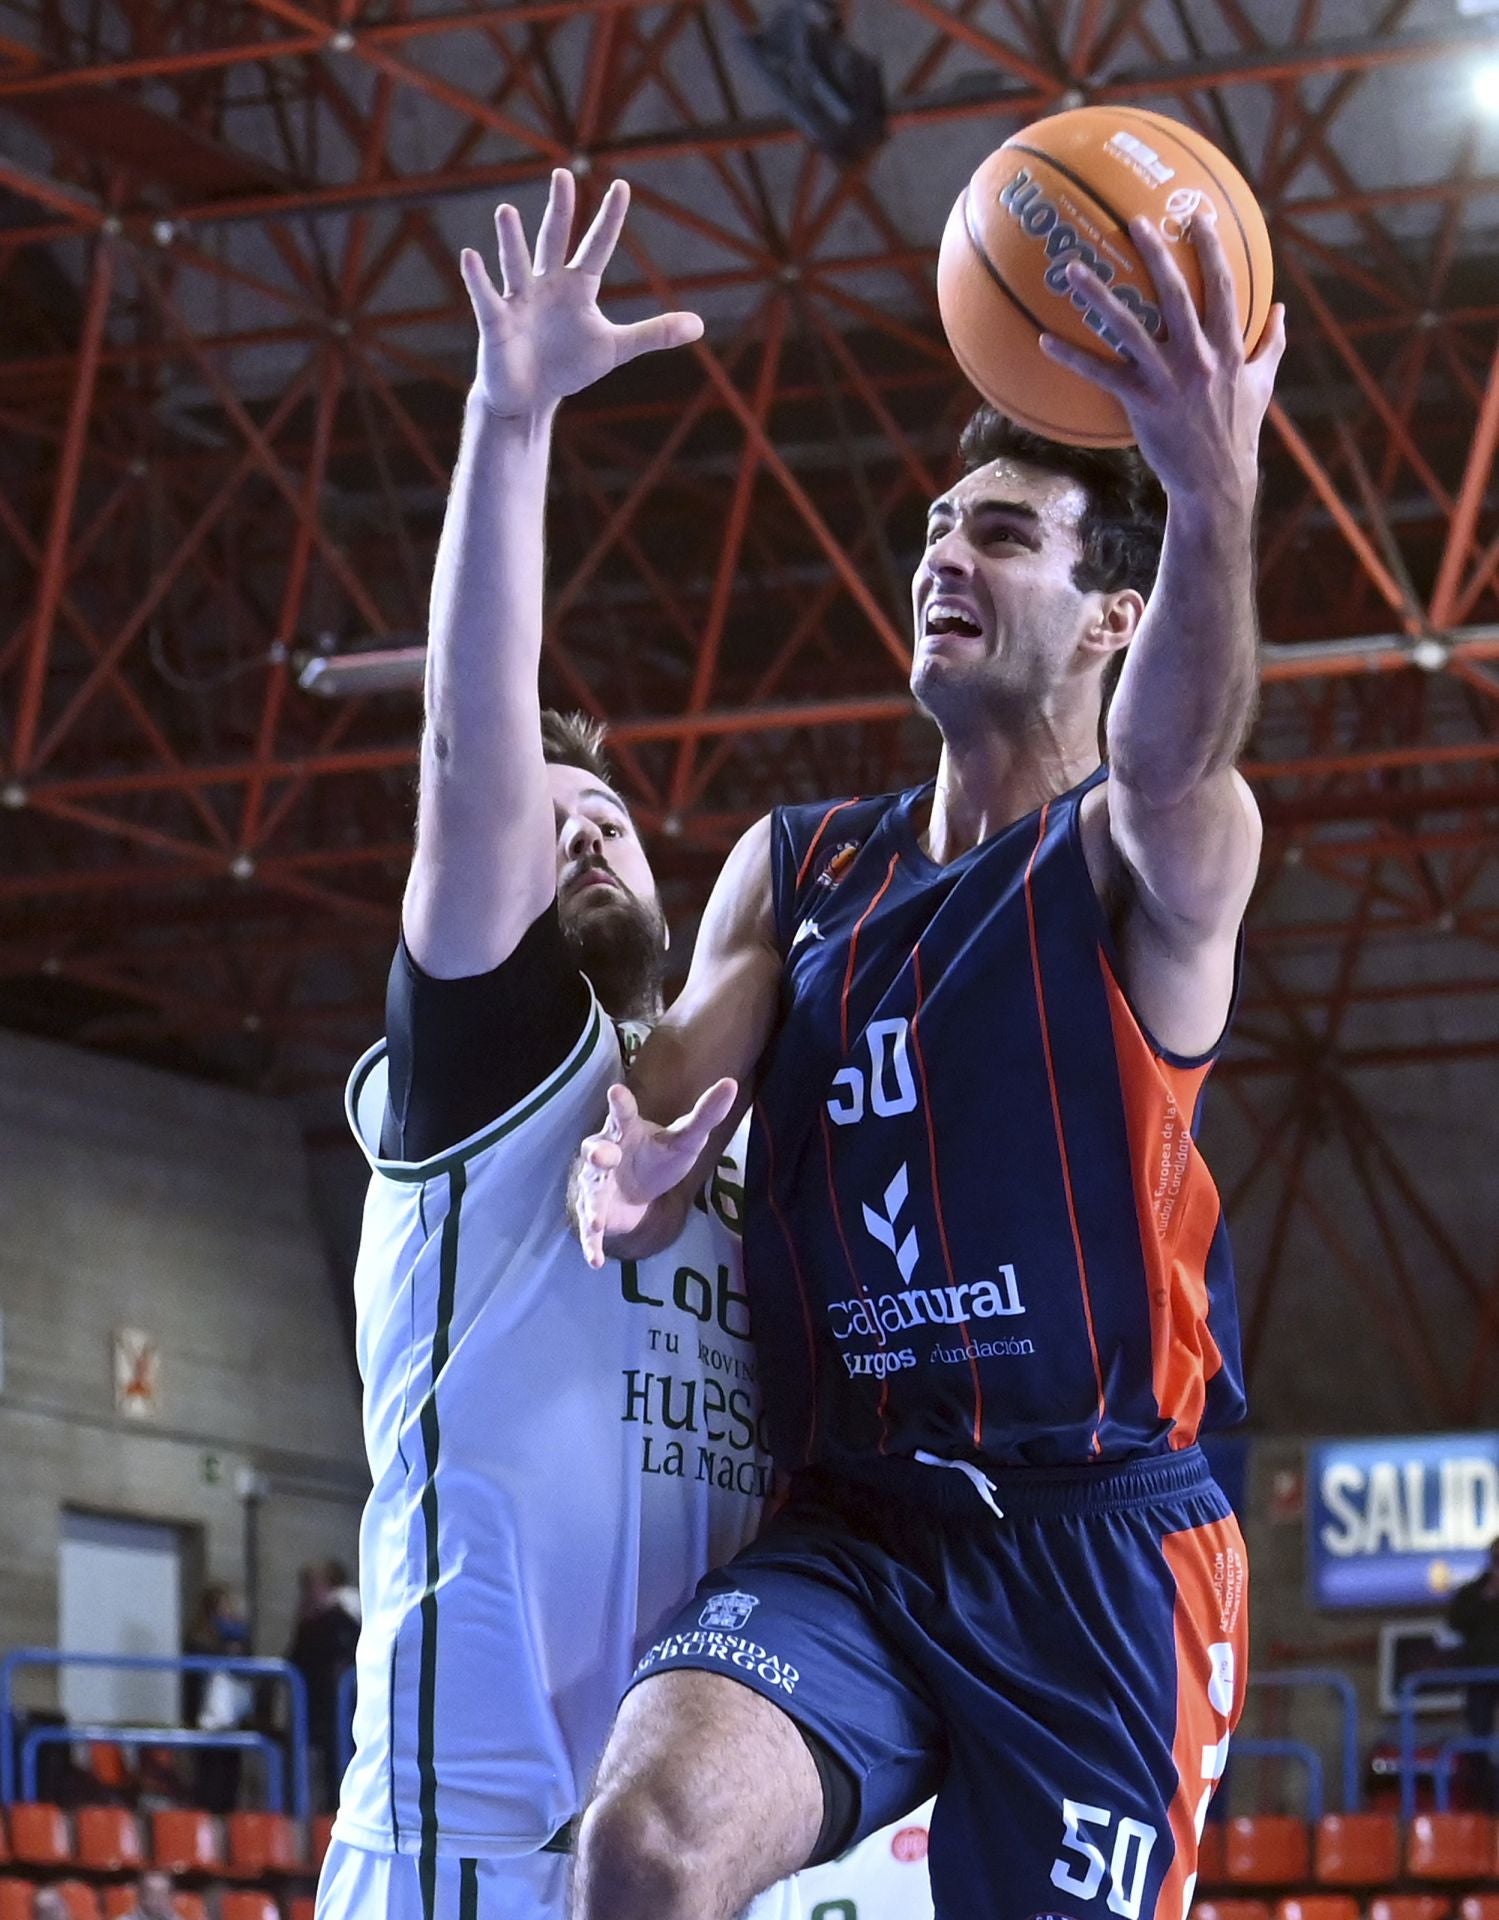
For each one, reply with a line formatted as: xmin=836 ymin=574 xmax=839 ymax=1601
xmin=1042 ymin=215 xmax=1286 ymax=511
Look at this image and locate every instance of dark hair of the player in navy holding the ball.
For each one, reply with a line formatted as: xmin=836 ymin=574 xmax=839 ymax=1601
xmin=958 ymin=405 xmax=1165 ymax=753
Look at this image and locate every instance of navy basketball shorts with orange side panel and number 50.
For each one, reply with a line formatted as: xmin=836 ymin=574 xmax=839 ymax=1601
xmin=631 ymin=1448 xmax=1248 ymax=1920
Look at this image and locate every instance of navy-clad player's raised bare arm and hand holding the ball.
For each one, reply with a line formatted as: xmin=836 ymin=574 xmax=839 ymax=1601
xmin=1046 ymin=221 xmax=1286 ymax=1054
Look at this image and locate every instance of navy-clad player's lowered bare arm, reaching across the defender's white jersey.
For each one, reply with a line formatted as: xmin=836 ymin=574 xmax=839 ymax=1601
xmin=570 ymin=818 xmax=781 ymax=1267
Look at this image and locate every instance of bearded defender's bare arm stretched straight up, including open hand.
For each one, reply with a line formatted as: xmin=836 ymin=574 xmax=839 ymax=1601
xmin=403 ymin=169 xmax=702 ymax=979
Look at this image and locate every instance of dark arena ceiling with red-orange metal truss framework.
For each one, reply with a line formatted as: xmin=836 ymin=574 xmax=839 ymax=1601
xmin=0 ymin=0 xmax=1499 ymax=1417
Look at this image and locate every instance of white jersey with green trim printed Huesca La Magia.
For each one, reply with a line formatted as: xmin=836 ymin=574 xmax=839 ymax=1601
xmin=334 ymin=1002 xmax=770 ymax=1857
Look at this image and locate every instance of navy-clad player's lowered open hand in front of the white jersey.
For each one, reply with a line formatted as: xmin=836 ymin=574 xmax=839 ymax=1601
xmin=572 ymin=1079 xmax=739 ymax=1267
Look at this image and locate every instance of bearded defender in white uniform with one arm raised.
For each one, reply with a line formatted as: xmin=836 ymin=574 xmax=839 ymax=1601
xmin=317 ymin=173 xmax=931 ymax=1920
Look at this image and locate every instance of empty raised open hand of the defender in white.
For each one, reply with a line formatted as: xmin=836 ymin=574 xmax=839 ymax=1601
xmin=459 ymin=167 xmax=702 ymax=419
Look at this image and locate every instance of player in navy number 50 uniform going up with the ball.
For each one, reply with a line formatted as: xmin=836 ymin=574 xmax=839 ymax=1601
xmin=574 ymin=219 xmax=1284 ymax=1920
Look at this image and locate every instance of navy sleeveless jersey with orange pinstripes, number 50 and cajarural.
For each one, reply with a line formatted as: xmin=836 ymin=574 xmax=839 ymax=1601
xmin=745 ymin=770 xmax=1244 ymax=1471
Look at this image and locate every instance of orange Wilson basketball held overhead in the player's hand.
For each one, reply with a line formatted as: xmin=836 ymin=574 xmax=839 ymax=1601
xmin=937 ymin=106 xmax=1271 ymax=447
